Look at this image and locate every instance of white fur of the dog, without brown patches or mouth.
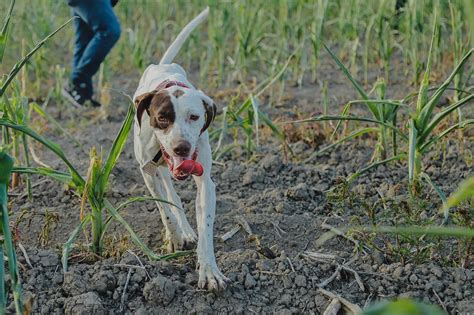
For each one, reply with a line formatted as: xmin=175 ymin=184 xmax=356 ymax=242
xmin=133 ymin=8 xmax=228 ymax=290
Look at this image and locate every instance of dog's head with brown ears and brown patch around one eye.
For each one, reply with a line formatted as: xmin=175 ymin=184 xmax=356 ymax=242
xmin=135 ymin=86 xmax=216 ymax=166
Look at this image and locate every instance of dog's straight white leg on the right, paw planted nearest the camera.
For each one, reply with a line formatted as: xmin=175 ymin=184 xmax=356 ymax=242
xmin=194 ymin=138 xmax=229 ymax=290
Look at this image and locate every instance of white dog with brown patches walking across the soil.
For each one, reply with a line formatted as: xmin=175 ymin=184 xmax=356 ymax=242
xmin=133 ymin=8 xmax=229 ymax=290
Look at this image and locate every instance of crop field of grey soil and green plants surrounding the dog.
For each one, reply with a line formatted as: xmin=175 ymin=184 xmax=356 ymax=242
xmin=0 ymin=0 xmax=474 ymax=314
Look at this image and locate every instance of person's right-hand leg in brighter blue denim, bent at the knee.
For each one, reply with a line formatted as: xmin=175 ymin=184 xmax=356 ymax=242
xmin=72 ymin=0 xmax=120 ymax=98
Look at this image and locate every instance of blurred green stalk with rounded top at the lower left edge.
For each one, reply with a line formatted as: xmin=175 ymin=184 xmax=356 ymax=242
xmin=0 ymin=152 xmax=23 ymax=314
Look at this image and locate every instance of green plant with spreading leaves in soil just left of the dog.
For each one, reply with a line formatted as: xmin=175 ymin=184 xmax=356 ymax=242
xmin=0 ymin=99 xmax=185 ymax=270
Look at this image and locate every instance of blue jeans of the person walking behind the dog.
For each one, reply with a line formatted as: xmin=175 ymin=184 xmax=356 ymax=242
xmin=67 ymin=0 xmax=121 ymax=98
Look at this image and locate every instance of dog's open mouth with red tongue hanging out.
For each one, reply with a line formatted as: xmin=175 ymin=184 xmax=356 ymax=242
xmin=161 ymin=146 xmax=204 ymax=180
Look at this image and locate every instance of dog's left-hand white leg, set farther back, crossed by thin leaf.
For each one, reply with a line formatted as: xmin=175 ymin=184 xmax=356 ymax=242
xmin=142 ymin=167 xmax=197 ymax=252
